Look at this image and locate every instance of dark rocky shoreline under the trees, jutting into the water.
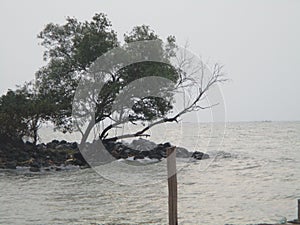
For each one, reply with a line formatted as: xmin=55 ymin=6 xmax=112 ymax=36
xmin=0 ymin=139 xmax=209 ymax=172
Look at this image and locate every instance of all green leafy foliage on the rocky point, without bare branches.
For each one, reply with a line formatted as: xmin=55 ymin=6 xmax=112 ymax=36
xmin=0 ymin=13 xmax=179 ymax=144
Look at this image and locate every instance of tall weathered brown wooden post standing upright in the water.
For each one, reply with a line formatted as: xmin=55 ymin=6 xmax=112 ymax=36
xmin=167 ymin=147 xmax=178 ymax=225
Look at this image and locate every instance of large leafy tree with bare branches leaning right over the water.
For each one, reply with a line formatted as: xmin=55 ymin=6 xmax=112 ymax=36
xmin=36 ymin=14 xmax=224 ymax=146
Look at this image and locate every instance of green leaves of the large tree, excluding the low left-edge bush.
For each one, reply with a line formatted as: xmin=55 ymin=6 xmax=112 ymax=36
xmin=36 ymin=14 xmax=179 ymax=137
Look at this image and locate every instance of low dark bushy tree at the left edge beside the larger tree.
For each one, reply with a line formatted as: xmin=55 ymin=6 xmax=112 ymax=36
xmin=0 ymin=82 xmax=50 ymax=145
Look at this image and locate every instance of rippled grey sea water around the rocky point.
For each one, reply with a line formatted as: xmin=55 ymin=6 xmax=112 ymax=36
xmin=0 ymin=122 xmax=300 ymax=225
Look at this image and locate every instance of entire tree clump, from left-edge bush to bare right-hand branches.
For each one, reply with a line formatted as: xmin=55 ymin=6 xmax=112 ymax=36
xmin=0 ymin=13 xmax=224 ymax=146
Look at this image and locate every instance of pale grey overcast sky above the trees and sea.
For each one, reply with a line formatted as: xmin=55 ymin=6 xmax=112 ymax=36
xmin=0 ymin=0 xmax=300 ymax=121
